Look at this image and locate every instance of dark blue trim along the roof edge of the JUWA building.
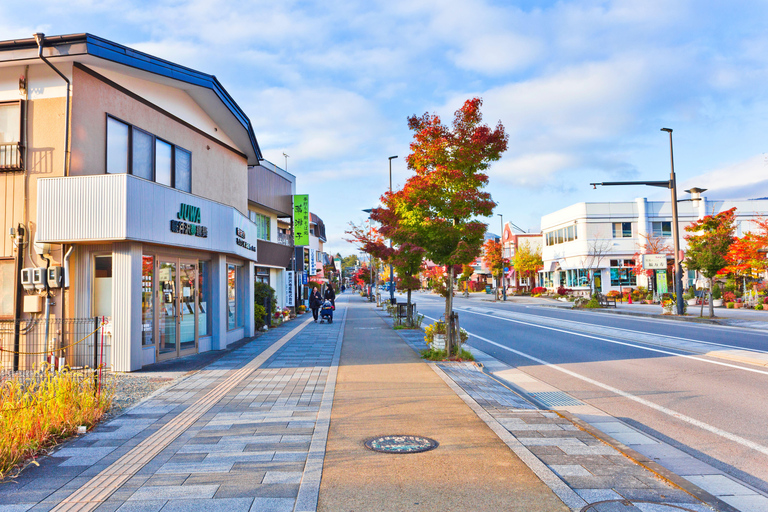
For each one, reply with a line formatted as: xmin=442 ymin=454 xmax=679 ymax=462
xmin=6 ymin=34 xmax=263 ymax=160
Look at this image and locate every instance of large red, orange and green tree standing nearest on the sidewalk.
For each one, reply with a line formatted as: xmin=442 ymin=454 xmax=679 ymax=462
xmin=398 ymin=98 xmax=508 ymax=354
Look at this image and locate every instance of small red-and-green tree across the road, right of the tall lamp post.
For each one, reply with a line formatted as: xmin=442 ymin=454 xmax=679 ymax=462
xmin=685 ymin=208 xmax=736 ymax=318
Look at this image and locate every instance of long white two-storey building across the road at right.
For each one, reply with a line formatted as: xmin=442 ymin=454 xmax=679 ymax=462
xmin=538 ymin=197 xmax=768 ymax=293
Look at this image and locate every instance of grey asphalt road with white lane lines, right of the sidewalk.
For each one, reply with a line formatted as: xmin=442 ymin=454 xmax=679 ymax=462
xmin=414 ymin=294 xmax=768 ymax=492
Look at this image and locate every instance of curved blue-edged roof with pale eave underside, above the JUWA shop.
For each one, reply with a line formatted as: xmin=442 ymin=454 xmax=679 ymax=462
xmin=0 ymin=33 xmax=262 ymax=165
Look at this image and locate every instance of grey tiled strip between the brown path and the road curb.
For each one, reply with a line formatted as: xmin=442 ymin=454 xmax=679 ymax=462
xmin=398 ymin=312 xmax=712 ymax=512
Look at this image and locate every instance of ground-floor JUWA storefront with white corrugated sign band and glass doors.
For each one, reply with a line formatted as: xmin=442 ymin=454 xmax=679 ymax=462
xmin=38 ymin=174 xmax=257 ymax=371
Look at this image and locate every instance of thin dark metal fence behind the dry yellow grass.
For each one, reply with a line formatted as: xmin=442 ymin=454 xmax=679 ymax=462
xmin=0 ymin=317 xmax=112 ymax=381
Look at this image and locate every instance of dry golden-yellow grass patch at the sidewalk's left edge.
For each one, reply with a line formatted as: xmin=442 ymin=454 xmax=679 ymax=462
xmin=0 ymin=368 xmax=114 ymax=479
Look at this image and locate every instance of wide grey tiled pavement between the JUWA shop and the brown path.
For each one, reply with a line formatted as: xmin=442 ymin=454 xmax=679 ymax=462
xmin=0 ymin=308 xmax=343 ymax=512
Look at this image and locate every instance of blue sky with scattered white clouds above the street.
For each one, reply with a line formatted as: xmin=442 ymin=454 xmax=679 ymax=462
xmin=0 ymin=0 xmax=768 ymax=255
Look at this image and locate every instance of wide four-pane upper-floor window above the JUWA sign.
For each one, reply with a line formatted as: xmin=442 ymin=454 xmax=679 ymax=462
xmin=107 ymin=116 xmax=192 ymax=192
